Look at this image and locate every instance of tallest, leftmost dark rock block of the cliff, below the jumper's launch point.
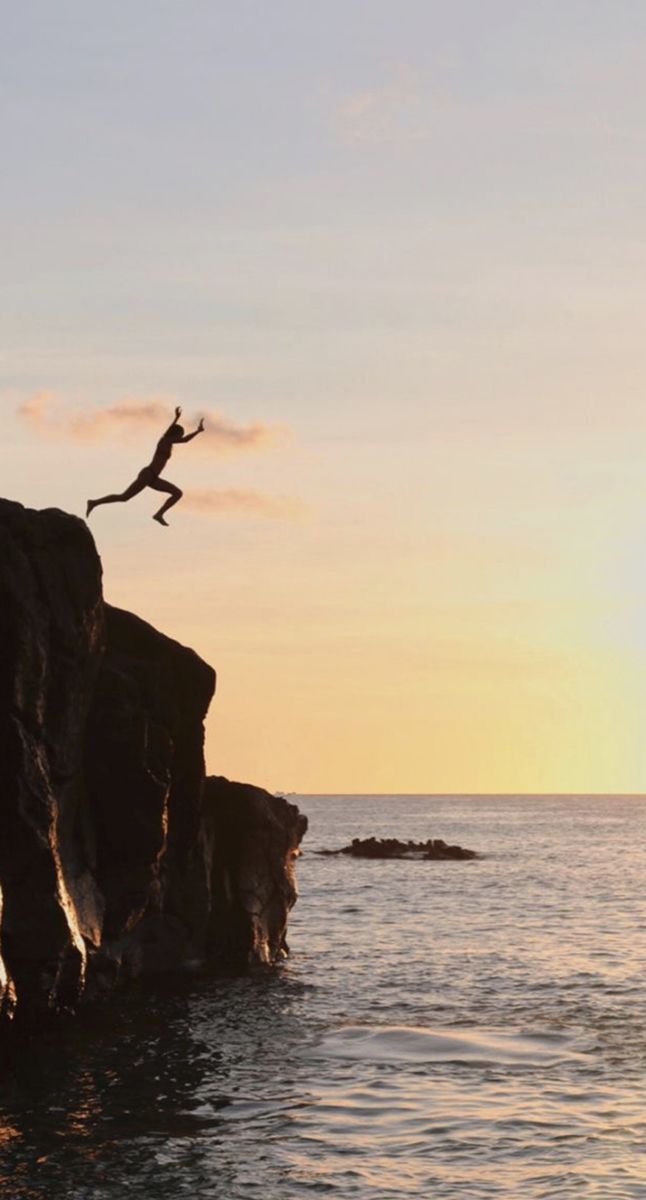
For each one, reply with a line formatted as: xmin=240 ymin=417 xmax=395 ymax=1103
xmin=0 ymin=500 xmax=104 ymax=1008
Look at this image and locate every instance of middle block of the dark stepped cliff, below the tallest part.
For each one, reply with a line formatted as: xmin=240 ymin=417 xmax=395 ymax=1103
xmin=85 ymin=605 xmax=215 ymax=972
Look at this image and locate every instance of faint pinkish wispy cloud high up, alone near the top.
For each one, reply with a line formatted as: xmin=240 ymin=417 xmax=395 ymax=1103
xmin=335 ymin=64 xmax=432 ymax=144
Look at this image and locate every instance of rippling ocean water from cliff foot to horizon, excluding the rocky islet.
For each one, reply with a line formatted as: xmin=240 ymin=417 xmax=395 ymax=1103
xmin=0 ymin=796 xmax=646 ymax=1200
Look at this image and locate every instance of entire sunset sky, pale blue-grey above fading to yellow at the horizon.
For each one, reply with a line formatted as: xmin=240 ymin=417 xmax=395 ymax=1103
xmin=0 ymin=0 xmax=646 ymax=792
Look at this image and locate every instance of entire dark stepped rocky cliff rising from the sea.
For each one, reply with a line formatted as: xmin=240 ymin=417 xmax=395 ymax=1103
xmin=0 ymin=500 xmax=306 ymax=1026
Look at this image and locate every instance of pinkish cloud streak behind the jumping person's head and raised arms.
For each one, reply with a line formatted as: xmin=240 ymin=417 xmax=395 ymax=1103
xmin=18 ymin=392 xmax=288 ymax=455
